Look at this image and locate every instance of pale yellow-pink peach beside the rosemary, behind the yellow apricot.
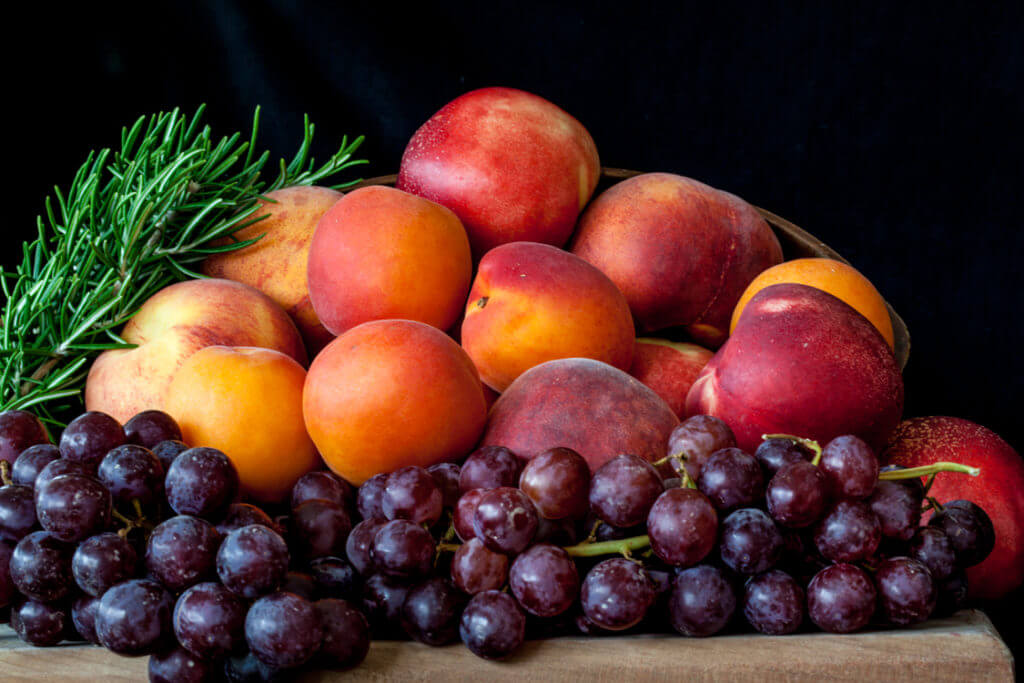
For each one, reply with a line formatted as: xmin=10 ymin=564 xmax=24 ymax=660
xmin=85 ymin=280 xmax=306 ymax=423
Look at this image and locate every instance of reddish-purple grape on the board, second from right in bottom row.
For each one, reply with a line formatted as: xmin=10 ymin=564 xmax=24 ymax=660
xmin=807 ymin=563 xmax=877 ymax=633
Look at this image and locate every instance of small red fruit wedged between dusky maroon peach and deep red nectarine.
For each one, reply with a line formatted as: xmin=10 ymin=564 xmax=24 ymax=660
xmin=630 ymin=337 xmax=715 ymax=419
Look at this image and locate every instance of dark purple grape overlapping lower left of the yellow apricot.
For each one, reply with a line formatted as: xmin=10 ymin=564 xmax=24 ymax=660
xmin=164 ymin=449 xmax=239 ymax=520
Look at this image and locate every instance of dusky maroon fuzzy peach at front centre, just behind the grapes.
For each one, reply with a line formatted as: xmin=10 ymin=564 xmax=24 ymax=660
xmin=481 ymin=358 xmax=679 ymax=471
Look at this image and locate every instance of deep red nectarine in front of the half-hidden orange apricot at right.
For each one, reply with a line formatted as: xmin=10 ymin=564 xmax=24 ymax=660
xmin=686 ymin=284 xmax=903 ymax=453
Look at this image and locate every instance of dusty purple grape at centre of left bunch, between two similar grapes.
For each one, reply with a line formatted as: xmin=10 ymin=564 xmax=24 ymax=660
xmin=145 ymin=515 xmax=220 ymax=593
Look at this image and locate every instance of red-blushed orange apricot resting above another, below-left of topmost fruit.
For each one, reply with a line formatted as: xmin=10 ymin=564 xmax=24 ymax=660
xmin=307 ymin=185 xmax=473 ymax=334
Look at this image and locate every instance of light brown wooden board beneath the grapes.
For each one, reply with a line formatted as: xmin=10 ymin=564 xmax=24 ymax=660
xmin=0 ymin=610 xmax=1014 ymax=683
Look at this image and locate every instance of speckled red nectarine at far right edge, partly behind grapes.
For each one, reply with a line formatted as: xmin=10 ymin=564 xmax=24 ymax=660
xmin=882 ymin=417 xmax=1024 ymax=600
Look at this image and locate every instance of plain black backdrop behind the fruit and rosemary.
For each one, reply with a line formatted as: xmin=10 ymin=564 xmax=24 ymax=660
xmin=0 ymin=1 xmax=1024 ymax=656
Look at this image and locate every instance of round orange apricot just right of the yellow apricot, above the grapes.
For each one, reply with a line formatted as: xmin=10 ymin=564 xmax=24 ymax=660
xmin=302 ymin=321 xmax=487 ymax=485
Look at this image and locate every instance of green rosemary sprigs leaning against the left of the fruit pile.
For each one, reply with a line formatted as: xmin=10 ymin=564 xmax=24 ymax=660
xmin=0 ymin=108 xmax=366 ymax=424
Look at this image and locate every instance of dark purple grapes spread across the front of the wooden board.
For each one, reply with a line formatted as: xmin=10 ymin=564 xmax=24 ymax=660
xmin=0 ymin=405 xmax=994 ymax=680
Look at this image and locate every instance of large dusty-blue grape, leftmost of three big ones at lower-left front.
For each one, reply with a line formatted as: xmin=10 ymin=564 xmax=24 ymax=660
xmin=96 ymin=579 xmax=174 ymax=655
